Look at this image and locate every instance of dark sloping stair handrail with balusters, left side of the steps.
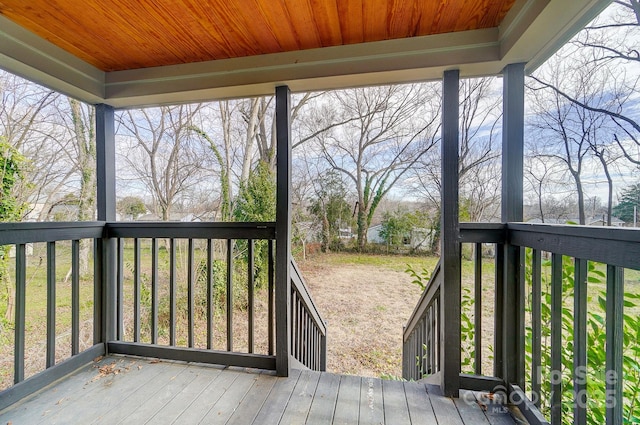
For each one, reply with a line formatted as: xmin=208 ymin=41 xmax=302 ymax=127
xmin=289 ymin=260 xmax=327 ymax=371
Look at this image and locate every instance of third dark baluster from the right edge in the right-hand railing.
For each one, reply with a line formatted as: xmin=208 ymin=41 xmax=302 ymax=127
xmin=550 ymin=253 xmax=562 ymax=425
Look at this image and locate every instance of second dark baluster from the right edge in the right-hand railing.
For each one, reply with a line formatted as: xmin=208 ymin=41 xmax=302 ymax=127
xmin=573 ymin=258 xmax=587 ymax=424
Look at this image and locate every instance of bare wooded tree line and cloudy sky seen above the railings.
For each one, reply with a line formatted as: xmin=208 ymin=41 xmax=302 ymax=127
xmin=0 ymin=0 xmax=640 ymax=249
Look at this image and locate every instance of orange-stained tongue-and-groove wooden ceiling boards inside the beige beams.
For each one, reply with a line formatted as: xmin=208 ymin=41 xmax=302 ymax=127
xmin=0 ymin=0 xmax=515 ymax=71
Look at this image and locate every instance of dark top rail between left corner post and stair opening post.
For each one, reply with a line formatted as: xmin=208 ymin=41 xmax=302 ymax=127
xmin=106 ymin=221 xmax=276 ymax=239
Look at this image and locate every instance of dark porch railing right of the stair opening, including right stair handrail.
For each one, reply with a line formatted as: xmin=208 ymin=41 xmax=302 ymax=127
xmin=403 ymin=223 xmax=640 ymax=425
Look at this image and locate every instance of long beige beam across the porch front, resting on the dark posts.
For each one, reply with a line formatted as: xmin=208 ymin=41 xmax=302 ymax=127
xmin=105 ymin=28 xmax=502 ymax=107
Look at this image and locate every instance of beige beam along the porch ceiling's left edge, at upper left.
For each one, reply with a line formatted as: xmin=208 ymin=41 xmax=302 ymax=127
xmin=0 ymin=16 xmax=105 ymax=103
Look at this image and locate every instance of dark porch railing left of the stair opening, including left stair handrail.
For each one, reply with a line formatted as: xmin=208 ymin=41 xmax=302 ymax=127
xmin=0 ymin=222 xmax=326 ymax=410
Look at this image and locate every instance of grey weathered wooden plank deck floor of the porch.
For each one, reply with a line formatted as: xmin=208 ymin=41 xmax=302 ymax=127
xmin=0 ymin=357 xmax=520 ymax=425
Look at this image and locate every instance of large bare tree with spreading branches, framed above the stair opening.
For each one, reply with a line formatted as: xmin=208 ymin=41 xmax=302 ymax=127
xmin=316 ymin=85 xmax=439 ymax=249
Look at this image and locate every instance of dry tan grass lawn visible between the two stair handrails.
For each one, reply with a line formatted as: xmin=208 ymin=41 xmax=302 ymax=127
xmin=299 ymin=253 xmax=436 ymax=377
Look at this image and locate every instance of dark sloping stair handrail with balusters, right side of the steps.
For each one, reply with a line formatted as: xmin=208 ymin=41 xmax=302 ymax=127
xmin=402 ymin=262 xmax=442 ymax=380
